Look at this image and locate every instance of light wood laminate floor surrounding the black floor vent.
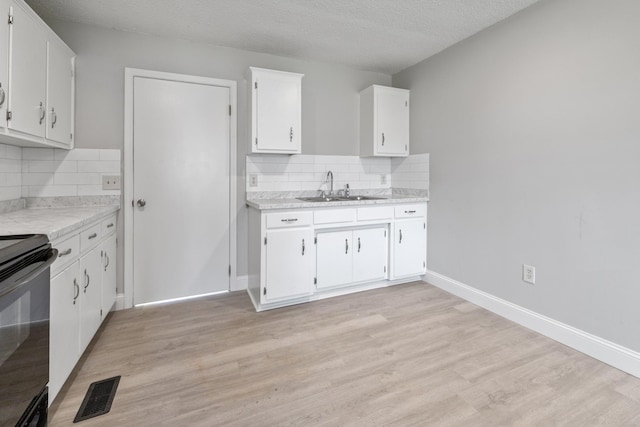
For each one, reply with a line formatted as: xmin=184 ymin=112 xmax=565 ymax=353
xmin=50 ymin=282 xmax=640 ymax=427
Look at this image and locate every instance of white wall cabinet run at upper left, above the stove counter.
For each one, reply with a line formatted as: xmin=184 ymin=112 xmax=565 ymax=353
xmin=0 ymin=0 xmax=75 ymax=149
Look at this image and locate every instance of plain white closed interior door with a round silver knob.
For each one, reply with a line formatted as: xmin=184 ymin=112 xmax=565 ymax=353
xmin=132 ymin=77 xmax=231 ymax=304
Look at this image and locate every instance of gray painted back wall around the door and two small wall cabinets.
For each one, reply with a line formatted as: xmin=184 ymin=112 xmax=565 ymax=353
xmin=47 ymin=20 xmax=391 ymax=283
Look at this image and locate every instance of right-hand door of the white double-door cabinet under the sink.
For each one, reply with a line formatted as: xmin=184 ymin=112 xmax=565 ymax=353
xmin=352 ymin=227 xmax=389 ymax=282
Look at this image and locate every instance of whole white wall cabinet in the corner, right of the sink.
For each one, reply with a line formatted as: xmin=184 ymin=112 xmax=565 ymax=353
xmin=360 ymin=85 xmax=410 ymax=157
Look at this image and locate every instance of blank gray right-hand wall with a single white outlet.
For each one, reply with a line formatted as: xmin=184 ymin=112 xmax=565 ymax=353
xmin=393 ymin=0 xmax=640 ymax=351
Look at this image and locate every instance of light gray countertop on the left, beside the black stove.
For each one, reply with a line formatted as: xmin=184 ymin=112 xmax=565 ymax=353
xmin=0 ymin=206 xmax=120 ymax=240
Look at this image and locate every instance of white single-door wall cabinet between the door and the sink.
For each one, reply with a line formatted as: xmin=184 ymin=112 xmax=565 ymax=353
xmin=247 ymin=67 xmax=303 ymax=154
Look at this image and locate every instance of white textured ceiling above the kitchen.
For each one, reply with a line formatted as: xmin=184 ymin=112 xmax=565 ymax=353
xmin=27 ymin=0 xmax=538 ymax=74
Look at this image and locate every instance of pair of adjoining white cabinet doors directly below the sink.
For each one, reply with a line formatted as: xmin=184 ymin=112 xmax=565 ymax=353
xmin=317 ymin=226 xmax=388 ymax=289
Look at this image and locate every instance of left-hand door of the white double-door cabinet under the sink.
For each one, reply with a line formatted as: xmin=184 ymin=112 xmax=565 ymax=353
xmin=316 ymin=230 xmax=354 ymax=289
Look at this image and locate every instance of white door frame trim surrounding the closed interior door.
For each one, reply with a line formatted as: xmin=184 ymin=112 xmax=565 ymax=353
xmin=122 ymin=67 xmax=238 ymax=308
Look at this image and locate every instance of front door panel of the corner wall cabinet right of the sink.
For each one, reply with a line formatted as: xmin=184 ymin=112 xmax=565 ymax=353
xmin=375 ymin=90 xmax=409 ymax=155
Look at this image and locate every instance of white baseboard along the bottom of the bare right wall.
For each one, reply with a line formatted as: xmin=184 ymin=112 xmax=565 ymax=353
xmin=424 ymin=271 xmax=640 ymax=378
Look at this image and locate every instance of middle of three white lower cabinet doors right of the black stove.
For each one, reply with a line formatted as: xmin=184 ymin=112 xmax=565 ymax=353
xmin=80 ymin=247 xmax=102 ymax=353
